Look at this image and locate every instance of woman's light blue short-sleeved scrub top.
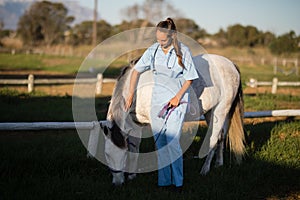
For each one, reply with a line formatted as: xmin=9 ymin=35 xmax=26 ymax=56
xmin=134 ymin=43 xmax=198 ymax=107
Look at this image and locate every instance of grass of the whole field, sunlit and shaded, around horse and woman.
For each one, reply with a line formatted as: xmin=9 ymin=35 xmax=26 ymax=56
xmin=0 ymin=50 xmax=300 ymax=200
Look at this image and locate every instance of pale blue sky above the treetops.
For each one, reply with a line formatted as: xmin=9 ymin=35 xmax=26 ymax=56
xmin=77 ymin=0 xmax=300 ymax=35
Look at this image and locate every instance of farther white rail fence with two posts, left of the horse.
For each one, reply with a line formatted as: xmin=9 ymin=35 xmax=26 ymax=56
xmin=0 ymin=74 xmax=116 ymax=95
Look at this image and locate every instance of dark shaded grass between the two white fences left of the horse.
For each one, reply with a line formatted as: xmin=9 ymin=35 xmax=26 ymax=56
xmin=0 ymin=93 xmax=111 ymax=122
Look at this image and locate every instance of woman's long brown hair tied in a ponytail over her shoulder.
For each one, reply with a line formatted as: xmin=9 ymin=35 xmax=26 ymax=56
xmin=156 ymin=18 xmax=184 ymax=68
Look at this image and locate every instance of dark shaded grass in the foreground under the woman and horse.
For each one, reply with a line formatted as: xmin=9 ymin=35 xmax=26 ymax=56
xmin=0 ymin=120 xmax=300 ymax=200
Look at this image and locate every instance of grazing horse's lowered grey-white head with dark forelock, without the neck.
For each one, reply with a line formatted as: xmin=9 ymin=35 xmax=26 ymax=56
xmin=101 ymin=122 xmax=127 ymax=186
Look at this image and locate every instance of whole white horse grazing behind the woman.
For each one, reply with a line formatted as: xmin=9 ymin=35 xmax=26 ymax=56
xmin=101 ymin=54 xmax=245 ymax=185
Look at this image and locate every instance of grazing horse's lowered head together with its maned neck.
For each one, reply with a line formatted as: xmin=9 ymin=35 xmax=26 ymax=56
xmin=101 ymin=59 xmax=142 ymax=185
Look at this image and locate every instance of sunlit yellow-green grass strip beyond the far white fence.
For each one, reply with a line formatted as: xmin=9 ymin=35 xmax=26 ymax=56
xmin=0 ymin=47 xmax=300 ymax=82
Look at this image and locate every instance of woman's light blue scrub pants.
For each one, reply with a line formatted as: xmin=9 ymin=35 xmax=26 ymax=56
xmin=151 ymin=104 xmax=186 ymax=187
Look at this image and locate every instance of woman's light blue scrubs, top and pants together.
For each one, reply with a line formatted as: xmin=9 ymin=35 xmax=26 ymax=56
xmin=134 ymin=43 xmax=198 ymax=187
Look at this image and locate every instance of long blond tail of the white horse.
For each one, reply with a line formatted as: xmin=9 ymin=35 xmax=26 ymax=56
xmin=228 ymin=65 xmax=245 ymax=163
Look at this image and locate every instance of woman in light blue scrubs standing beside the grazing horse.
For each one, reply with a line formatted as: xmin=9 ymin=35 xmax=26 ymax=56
xmin=125 ymin=18 xmax=198 ymax=191
